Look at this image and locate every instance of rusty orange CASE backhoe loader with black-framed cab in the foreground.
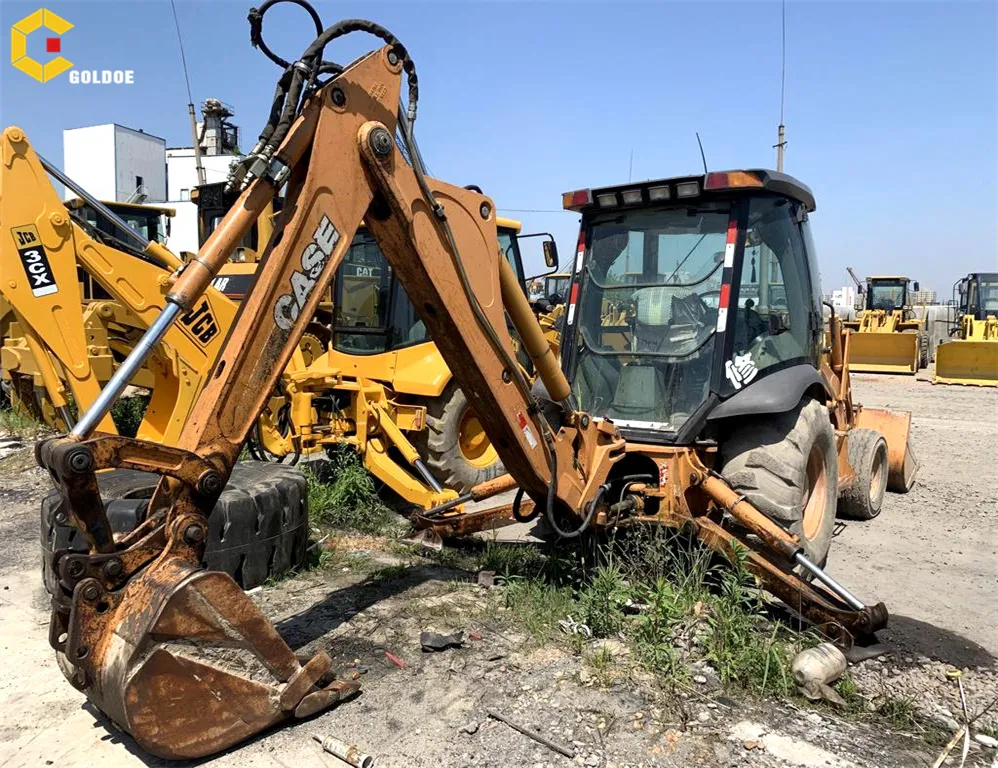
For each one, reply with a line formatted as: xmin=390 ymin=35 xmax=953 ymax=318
xmin=29 ymin=11 xmax=916 ymax=758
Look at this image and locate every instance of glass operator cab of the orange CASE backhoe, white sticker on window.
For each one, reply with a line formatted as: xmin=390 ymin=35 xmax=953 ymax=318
xmin=562 ymin=170 xmax=823 ymax=443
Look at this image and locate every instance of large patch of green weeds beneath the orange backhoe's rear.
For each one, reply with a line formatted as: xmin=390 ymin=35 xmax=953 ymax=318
xmin=482 ymin=529 xmax=818 ymax=695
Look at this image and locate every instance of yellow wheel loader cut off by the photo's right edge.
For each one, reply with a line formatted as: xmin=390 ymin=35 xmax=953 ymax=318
xmin=932 ymin=272 xmax=998 ymax=387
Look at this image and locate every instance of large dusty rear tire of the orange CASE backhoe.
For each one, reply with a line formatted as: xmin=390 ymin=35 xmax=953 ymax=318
xmin=720 ymin=399 xmax=838 ymax=565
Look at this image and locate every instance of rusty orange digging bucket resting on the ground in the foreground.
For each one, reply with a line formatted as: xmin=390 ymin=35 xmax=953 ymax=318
xmin=53 ymin=557 xmax=360 ymax=759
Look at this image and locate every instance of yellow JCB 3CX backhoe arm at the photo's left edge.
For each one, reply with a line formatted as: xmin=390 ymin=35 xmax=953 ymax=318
xmin=0 ymin=128 xmax=303 ymax=445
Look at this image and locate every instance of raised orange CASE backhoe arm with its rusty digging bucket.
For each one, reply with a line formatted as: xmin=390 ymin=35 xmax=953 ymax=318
xmin=37 ymin=45 xmax=624 ymax=758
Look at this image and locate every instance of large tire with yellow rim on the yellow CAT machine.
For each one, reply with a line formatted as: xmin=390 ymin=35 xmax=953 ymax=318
xmin=414 ymin=381 xmax=506 ymax=493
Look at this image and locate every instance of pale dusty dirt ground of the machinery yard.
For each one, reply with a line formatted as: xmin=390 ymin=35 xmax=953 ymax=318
xmin=0 ymin=368 xmax=998 ymax=768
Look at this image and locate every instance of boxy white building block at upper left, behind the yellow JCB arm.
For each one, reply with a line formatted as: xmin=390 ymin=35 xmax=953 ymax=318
xmin=62 ymin=123 xmax=166 ymax=203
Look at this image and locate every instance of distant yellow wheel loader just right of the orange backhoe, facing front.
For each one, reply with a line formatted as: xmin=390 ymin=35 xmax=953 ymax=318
xmin=843 ymin=276 xmax=929 ymax=374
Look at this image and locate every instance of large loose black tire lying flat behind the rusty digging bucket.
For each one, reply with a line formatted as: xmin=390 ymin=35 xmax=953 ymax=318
xmin=41 ymin=461 xmax=308 ymax=589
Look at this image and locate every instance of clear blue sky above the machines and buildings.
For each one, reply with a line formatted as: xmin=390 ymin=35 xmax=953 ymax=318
xmin=0 ymin=0 xmax=998 ymax=296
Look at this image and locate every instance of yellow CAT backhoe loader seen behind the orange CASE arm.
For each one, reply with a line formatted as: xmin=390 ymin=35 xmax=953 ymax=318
xmin=192 ymin=185 xmax=558 ymax=509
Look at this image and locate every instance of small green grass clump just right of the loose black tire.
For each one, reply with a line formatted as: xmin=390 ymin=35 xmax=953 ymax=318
xmin=302 ymin=446 xmax=397 ymax=535
